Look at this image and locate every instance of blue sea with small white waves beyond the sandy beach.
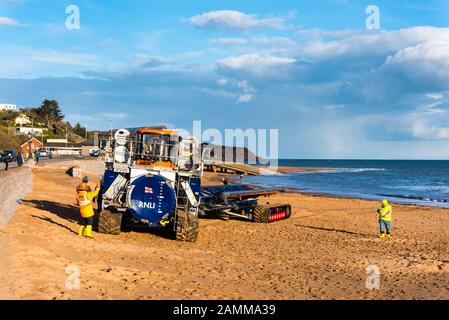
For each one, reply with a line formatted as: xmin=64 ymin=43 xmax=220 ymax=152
xmin=244 ymin=159 xmax=449 ymax=208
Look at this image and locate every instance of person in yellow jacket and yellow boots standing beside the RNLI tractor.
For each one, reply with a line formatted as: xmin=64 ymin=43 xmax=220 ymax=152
xmin=76 ymin=177 xmax=100 ymax=238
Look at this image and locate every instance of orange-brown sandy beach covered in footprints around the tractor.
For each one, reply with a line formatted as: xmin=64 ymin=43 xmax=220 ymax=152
xmin=0 ymin=160 xmax=449 ymax=300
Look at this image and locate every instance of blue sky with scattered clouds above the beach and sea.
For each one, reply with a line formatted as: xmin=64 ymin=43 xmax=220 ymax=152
xmin=0 ymin=0 xmax=449 ymax=159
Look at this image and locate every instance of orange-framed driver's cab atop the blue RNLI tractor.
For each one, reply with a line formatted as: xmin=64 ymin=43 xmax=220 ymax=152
xmin=134 ymin=129 xmax=179 ymax=168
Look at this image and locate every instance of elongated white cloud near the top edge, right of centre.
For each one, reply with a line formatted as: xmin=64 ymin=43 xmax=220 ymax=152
xmin=188 ymin=10 xmax=285 ymax=30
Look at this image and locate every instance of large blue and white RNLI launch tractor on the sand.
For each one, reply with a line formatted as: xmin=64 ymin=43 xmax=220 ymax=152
xmin=98 ymin=128 xmax=202 ymax=241
